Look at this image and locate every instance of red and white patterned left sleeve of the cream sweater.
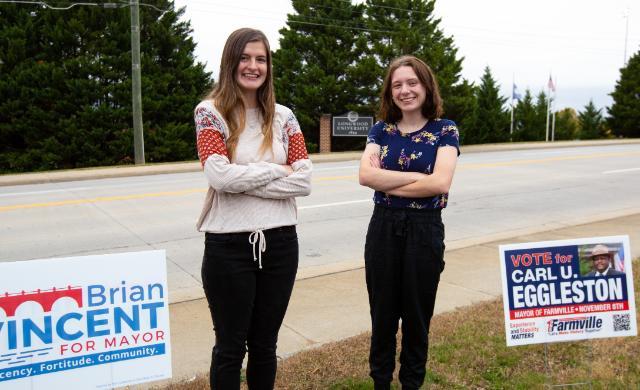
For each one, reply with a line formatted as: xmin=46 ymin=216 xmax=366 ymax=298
xmin=194 ymin=106 xmax=229 ymax=167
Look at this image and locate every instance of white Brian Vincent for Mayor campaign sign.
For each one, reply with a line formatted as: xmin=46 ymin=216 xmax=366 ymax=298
xmin=0 ymin=251 xmax=171 ymax=390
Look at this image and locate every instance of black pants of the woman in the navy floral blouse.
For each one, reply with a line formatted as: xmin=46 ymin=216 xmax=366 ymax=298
xmin=364 ymin=205 xmax=444 ymax=389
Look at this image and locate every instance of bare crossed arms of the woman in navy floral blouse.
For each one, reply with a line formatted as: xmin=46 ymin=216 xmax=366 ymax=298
xmin=359 ymin=144 xmax=458 ymax=198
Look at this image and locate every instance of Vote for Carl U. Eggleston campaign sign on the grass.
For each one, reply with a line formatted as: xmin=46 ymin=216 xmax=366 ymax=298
xmin=500 ymin=236 xmax=638 ymax=346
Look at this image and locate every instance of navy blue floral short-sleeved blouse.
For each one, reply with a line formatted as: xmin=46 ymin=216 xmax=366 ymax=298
xmin=367 ymin=119 xmax=460 ymax=209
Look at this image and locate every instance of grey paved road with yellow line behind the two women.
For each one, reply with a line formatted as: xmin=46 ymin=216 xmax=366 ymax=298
xmin=0 ymin=144 xmax=640 ymax=302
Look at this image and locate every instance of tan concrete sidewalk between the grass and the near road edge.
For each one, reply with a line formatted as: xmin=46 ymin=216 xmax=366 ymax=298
xmin=164 ymin=214 xmax=640 ymax=385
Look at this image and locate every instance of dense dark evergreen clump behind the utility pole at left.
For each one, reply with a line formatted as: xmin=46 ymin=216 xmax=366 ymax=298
xmin=0 ymin=0 xmax=211 ymax=172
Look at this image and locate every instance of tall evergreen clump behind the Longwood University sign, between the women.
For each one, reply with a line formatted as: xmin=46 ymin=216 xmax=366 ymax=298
xmin=274 ymin=0 xmax=473 ymax=150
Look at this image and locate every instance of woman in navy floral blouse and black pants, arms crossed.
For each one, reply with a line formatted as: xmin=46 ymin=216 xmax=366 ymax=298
xmin=359 ymin=56 xmax=460 ymax=389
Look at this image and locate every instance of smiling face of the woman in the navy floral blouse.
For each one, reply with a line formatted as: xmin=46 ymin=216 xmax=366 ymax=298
xmin=391 ymin=66 xmax=427 ymax=115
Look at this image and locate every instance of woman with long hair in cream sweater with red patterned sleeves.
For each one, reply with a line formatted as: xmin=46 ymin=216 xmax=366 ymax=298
xmin=195 ymin=28 xmax=312 ymax=390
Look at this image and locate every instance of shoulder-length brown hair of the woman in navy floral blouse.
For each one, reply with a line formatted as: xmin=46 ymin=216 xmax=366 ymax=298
xmin=378 ymin=56 xmax=443 ymax=123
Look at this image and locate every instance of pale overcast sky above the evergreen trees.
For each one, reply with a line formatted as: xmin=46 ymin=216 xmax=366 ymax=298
xmin=175 ymin=0 xmax=640 ymax=110
